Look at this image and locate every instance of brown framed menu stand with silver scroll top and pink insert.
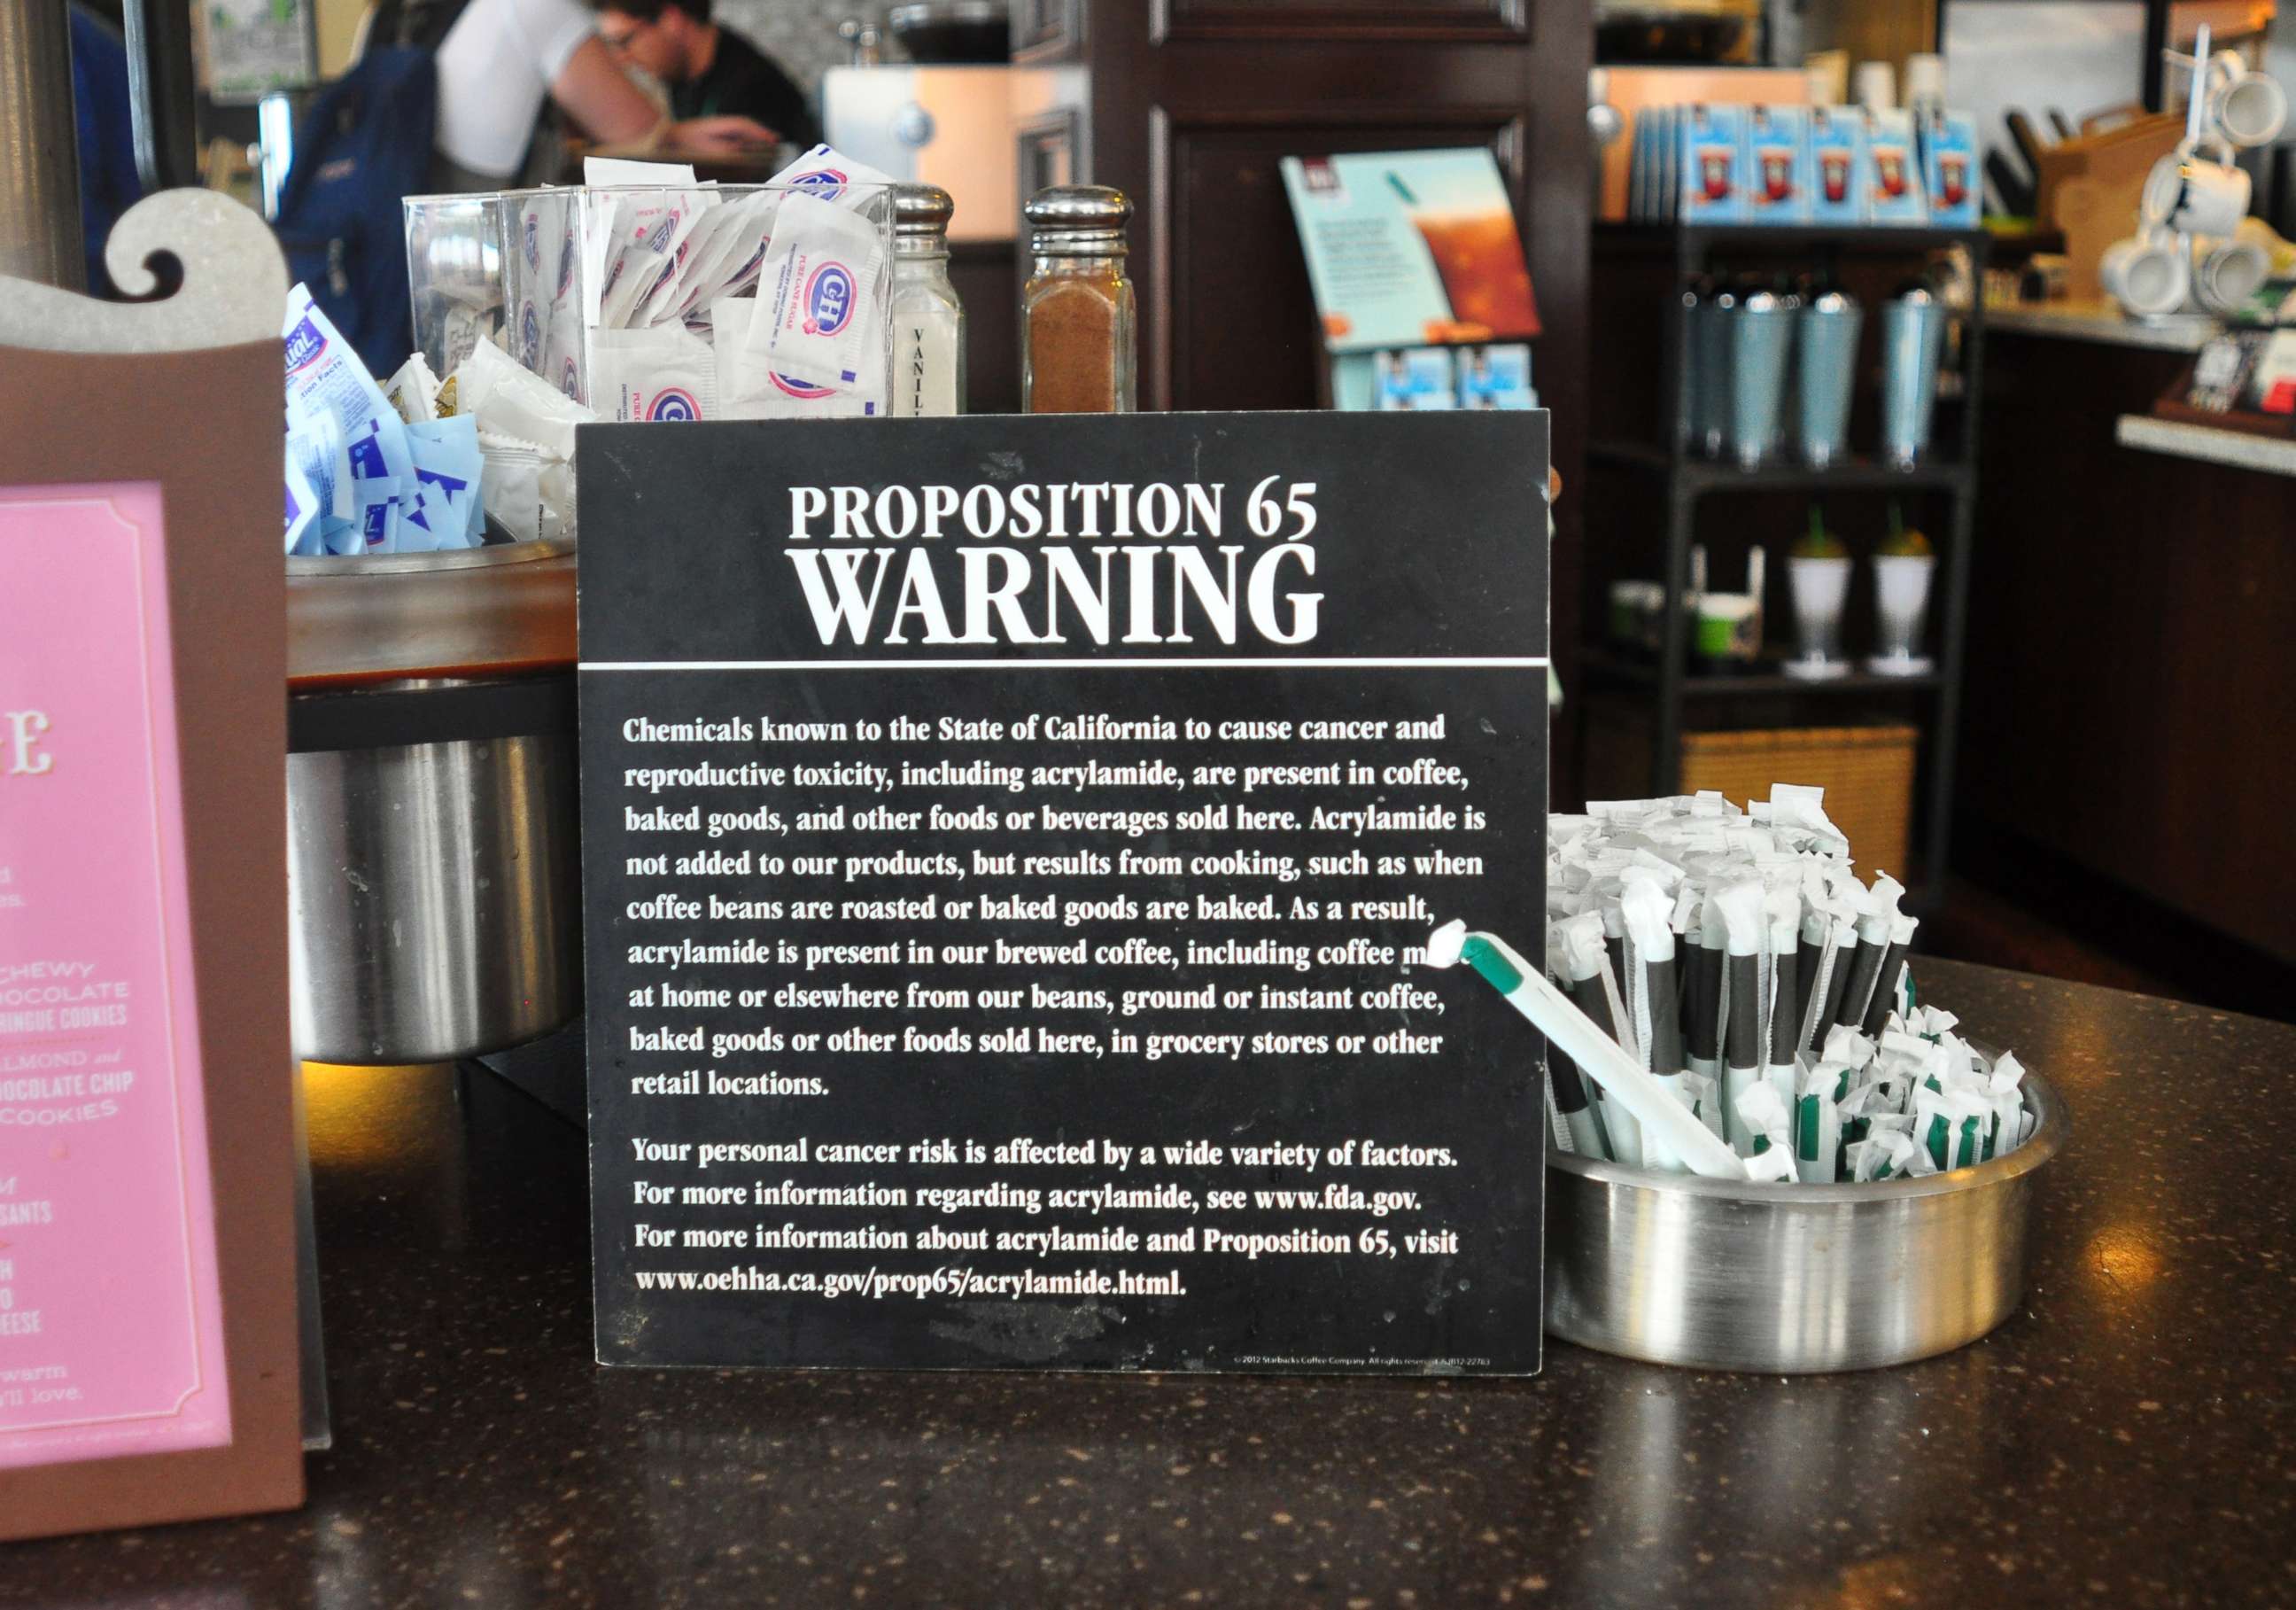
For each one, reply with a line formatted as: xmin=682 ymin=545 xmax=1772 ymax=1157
xmin=0 ymin=191 xmax=303 ymax=1534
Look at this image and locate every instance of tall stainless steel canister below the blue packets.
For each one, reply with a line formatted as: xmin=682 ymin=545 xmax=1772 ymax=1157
xmin=287 ymin=544 xmax=581 ymax=1063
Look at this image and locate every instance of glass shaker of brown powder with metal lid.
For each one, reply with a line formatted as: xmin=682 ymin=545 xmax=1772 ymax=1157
xmin=1020 ymin=183 xmax=1139 ymax=414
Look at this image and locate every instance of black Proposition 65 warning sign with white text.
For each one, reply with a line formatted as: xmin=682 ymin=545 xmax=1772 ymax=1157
xmin=578 ymin=411 xmax=1547 ymax=1373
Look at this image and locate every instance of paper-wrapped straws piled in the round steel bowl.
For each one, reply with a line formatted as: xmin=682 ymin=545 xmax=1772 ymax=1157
xmin=1547 ymin=783 xmax=2035 ymax=1185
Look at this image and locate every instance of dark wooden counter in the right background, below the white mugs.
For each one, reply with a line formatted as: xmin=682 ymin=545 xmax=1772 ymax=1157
xmin=1954 ymin=322 xmax=2296 ymax=967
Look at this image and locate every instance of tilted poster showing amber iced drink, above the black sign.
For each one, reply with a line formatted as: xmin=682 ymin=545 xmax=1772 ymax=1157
xmin=1284 ymin=149 xmax=1539 ymax=352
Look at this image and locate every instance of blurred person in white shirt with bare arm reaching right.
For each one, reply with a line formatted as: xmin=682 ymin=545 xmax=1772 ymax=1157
xmin=436 ymin=0 xmax=774 ymax=191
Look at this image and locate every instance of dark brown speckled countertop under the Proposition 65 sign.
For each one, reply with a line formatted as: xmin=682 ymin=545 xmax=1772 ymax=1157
xmin=0 ymin=962 xmax=2296 ymax=1610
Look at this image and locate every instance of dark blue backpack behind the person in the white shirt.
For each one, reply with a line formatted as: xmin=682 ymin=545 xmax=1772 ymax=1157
xmin=273 ymin=46 xmax=438 ymax=379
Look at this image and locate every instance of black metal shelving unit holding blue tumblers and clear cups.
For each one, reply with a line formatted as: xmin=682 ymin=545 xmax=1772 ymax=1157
xmin=1584 ymin=225 xmax=1989 ymax=909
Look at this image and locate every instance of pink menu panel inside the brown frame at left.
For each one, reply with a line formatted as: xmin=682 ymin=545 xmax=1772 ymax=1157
xmin=0 ymin=482 xmax=229 ymax=1467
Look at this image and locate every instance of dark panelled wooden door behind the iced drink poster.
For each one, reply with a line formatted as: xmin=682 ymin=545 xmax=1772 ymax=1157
xmin=1012 ymin=0 xmax=1594 ymax=799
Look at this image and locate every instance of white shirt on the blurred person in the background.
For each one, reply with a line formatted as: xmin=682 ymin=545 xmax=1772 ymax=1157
xmin=438 ymin=0 xmax=597 ymax=179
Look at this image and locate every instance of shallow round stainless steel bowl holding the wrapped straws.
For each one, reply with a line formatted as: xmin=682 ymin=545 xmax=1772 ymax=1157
xmin=1547 ymin=1072 xmax=2071 ymax=1373
